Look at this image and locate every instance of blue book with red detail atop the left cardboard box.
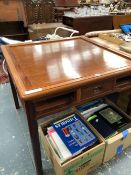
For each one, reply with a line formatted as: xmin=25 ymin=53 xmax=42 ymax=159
xmin=52 ymin=113 xmax=97 ymax=155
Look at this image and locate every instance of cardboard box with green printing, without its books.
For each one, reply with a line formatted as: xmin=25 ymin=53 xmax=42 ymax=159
xmin=39 ymin=112 xmax=105 ymax=175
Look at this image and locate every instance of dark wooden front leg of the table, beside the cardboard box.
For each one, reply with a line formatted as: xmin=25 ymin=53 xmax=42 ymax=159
xmin=25 ymin=102 xmax=43 ymax=175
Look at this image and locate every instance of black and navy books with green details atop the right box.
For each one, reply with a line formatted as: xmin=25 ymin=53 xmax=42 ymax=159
xmin=87 ymin=106 xmax=130 ymax=139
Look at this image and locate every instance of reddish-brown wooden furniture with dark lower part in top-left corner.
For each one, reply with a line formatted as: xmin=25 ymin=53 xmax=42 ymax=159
xmin=0 ymin=0 xmax=28 ymax=41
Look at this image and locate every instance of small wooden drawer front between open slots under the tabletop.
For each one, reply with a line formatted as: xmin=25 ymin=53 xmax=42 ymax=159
xmin=81 ymin=80 xmax=114 ymax=100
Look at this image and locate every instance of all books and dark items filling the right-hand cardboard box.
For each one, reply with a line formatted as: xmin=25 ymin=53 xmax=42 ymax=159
xmin=78 ymin=100 xmax=130 ymax=139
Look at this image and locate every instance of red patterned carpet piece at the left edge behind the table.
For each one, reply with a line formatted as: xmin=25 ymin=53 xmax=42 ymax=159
xmin=0 ymin=59 xmax=9 ymax=84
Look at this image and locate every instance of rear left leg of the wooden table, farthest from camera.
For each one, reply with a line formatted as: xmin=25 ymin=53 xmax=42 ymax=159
xmin=8 ymin=72 xmax=20 ymax=109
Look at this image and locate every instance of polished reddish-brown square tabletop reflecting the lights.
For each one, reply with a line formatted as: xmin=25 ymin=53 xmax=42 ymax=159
xmin=3 ymin=37 xmax=131 ymax=100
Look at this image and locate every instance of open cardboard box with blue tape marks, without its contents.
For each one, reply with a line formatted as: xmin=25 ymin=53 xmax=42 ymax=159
xmin=75 ymin=99 xmax=131 ymax=163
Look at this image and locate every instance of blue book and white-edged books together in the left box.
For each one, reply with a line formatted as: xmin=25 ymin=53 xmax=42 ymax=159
xmin=47 ymin=113 xmax=98 ymax=162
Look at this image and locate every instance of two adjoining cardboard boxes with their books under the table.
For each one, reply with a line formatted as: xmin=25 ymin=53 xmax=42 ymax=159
xmin=39 ymin=99 xmax=131 ymax=175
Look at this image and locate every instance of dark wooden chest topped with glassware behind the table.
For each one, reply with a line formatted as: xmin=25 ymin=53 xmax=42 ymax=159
xmin=63 ymin=15 xmax=131 ymax=35
